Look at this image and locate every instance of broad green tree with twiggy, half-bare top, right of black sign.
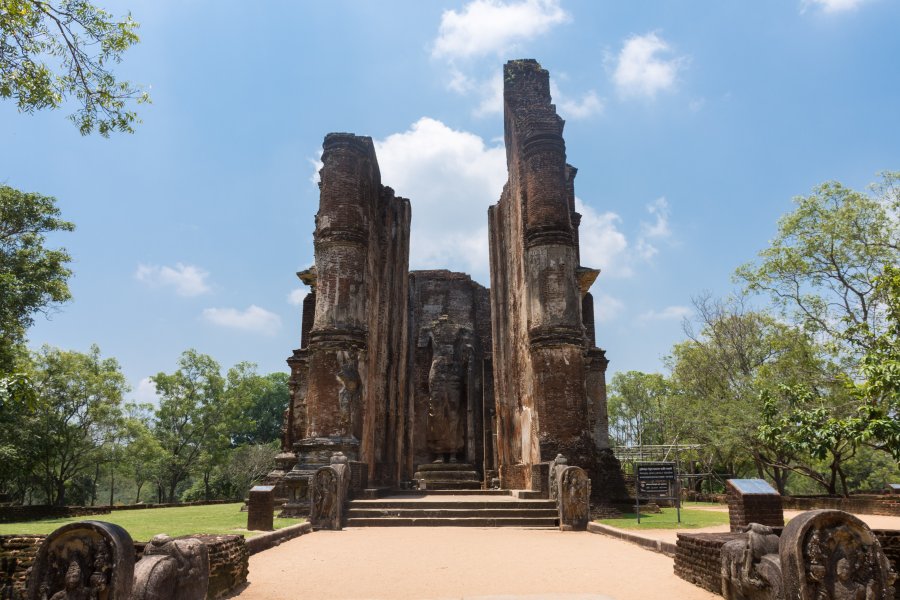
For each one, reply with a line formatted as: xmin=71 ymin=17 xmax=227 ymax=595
xmin=669 ymin=297 xmax=826 ymax=493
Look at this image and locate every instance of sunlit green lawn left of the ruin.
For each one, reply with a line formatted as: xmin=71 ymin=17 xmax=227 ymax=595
xmin=0 ymin=502 xmax=306 ymax=542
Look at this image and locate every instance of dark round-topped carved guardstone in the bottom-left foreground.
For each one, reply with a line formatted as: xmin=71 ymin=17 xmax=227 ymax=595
xmin=26 ymin=521 xmax=134 ymax=600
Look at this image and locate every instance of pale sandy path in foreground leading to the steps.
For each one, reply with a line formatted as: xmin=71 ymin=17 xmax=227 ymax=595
xmin=239 ymin=527 xmax=721 ymax=600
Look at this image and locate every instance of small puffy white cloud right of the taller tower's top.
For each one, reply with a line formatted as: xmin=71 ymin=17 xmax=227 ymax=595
xmin=613 ymin=32 xmax=686 ymax=98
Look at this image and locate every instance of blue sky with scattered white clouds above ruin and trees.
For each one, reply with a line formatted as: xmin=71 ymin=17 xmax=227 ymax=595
xmin=0 ymin=0 xmax=900 ymax=401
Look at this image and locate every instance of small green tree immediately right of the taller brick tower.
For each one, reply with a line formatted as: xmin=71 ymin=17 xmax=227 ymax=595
xmin=608 ymin=371 xmax=673 ymax=446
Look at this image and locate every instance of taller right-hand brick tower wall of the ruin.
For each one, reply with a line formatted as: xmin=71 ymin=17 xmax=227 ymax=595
xmin=489 ymin=60 xmax=622 ymax=496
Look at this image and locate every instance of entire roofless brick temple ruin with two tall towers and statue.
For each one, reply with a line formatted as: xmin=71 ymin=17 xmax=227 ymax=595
xmin=276 ymin=60 xmax=626 ymax=502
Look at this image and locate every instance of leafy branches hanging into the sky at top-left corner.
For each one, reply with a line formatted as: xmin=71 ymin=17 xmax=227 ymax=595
xmin=0 ymin=0 xmax=149 ymax=137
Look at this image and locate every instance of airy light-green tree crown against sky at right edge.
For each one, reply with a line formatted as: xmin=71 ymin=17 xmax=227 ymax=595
xmin=736 ymin=173 xmax=900 ymax=363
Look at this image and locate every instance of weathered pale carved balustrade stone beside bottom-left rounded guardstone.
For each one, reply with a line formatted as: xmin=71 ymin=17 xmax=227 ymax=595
xmin=131 ymin=534 xmax=209 ymax=600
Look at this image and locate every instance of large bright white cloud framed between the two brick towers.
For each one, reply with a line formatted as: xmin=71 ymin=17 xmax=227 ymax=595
xmin=375 ymin=117 xmax=506 ymax=284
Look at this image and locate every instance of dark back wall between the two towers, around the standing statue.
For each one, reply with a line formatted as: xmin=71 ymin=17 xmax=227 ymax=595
xmin=404 ymin=270 xmax=493 ymax=478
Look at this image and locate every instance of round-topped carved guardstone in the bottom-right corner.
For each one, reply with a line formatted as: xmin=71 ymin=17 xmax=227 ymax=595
xmin=779 ymin=510 xmax=896 ymax=600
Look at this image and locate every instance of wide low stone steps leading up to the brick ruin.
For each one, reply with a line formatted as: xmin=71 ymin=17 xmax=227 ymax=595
xmin=347 ymin=490 xmax=559 ymax=528
